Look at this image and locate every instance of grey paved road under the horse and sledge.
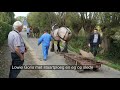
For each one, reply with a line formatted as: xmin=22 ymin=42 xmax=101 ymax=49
xmin=21 ymin=31 xmax=120 ymax=78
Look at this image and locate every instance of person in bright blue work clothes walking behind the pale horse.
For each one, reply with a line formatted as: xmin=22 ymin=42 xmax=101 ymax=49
xmin=38 ymin=30 xmax=52 ymax=61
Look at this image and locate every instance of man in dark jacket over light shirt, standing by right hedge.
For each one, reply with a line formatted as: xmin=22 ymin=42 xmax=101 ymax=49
xmin=88 ymin=29 xmax=101 ymax=56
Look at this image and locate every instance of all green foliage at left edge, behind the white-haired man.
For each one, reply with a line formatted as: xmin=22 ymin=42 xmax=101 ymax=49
xmin=0 ymin=12 xmax=15 ymax=46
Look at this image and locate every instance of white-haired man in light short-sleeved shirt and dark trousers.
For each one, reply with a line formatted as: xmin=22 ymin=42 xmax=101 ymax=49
xmin=8 ymin=21 xmax=27 ymax=78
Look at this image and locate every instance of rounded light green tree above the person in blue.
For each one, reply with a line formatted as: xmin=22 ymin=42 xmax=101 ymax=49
xmin=27 ymin=12 xmax=57 ymax=31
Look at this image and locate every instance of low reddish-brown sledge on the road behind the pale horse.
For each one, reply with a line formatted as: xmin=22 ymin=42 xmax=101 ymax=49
xmin=64 ymin=53 xmax=102 ymax=71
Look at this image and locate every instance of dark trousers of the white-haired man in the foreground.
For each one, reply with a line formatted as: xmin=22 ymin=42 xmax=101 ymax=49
xmin=9 ymin=53 xmax=24 ymax=78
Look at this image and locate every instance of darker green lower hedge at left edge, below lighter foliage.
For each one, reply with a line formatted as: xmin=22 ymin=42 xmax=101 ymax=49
xmin=0 ymin=22 xmax=12 ymax=46
